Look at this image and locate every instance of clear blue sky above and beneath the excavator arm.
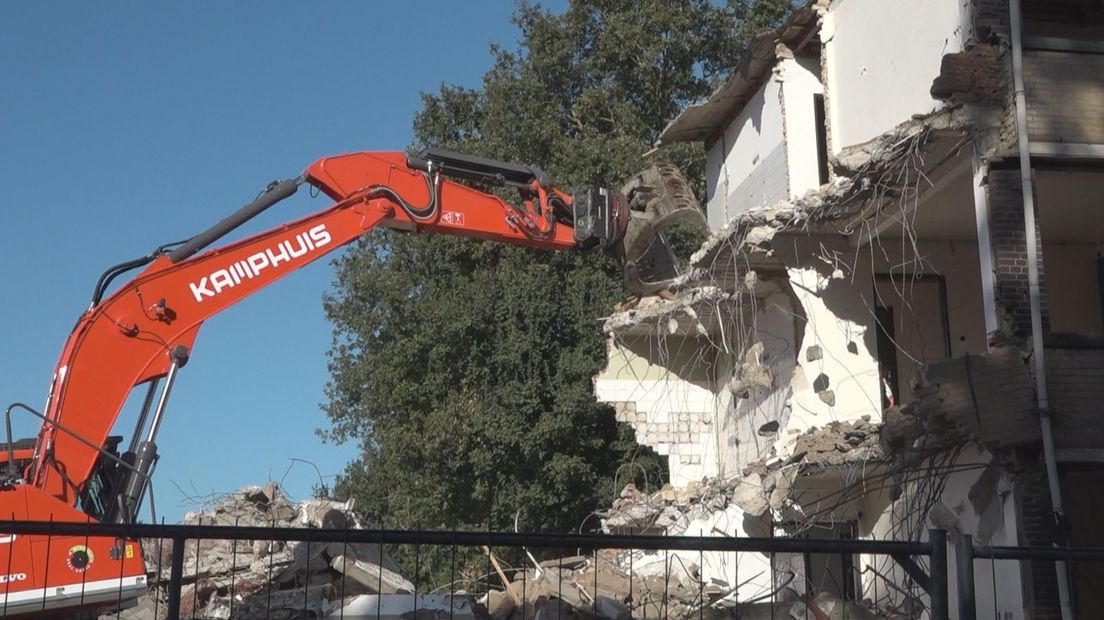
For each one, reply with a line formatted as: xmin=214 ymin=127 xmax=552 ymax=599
xmin=0 ymin=1 xmax=563 ymax=521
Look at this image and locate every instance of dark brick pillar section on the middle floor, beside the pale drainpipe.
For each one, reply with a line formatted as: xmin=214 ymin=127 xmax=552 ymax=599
xmin=988 ymin=168 xmax=1050 ymax=338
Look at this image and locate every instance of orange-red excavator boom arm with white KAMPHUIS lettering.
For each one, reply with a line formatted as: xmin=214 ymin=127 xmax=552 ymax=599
xmin=28 ymin=151 xmax=627 ymax=520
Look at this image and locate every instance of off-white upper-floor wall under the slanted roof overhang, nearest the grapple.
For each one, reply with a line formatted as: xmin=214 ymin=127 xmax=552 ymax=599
xmin=705 ymin=72 xmax=788 ymax=228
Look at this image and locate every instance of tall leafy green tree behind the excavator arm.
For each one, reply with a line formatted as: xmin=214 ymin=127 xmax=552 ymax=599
xmin=325 ymin=0 xmax=788 ymax=547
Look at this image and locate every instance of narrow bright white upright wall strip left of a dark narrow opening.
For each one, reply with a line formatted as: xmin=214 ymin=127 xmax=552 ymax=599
xmin=778 ymin=56 xmax=824 ymax=197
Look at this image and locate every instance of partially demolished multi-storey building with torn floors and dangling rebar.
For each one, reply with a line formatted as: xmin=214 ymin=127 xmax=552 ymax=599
xmin=596 ymin=0 xmax=1104 ymax=618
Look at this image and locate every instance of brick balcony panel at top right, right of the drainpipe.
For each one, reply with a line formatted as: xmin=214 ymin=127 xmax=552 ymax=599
xmin=1023 ymin=50 xmax=1104 ymax=145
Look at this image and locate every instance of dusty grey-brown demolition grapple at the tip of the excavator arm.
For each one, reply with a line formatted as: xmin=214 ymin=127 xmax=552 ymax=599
xmin=618 ymin=161 xmax=709 ymax=295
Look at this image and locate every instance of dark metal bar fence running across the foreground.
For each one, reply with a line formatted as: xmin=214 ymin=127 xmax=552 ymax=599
xmin=0 ymin=522 xmax=1104 ymax=620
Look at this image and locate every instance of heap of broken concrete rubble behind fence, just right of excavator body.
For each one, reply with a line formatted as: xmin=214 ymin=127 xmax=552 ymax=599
xmin=135 ymin=482 xmax=415 ymax=620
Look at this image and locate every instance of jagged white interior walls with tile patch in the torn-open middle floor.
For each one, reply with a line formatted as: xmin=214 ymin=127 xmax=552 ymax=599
xmin=595 ymin=239 xmax=881 ymax=487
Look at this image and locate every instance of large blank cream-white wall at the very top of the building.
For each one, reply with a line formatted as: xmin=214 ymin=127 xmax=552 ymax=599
xmin=820 ymin=0 xmax=964 ymax=152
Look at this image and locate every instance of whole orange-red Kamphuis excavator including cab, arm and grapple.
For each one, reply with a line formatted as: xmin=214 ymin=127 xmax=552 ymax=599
xmin=0 ymin=149 xmax=705 ymax=616
